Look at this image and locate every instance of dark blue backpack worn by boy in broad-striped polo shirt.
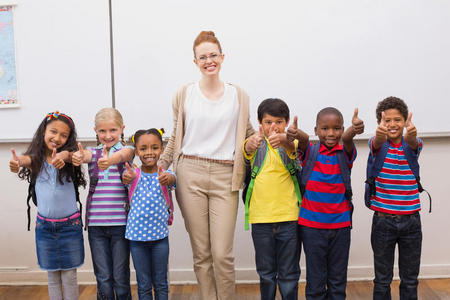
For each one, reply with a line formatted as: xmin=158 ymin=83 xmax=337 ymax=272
xmin=300 ymin=142 xmax=354 ymax=228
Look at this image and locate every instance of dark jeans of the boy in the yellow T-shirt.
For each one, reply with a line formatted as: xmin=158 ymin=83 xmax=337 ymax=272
xmin=252 ymin=221 xmax=300 ymax=300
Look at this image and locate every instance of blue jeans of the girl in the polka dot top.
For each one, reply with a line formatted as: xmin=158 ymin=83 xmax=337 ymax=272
xmin=130 ymin=237 xmax=169 ymax=300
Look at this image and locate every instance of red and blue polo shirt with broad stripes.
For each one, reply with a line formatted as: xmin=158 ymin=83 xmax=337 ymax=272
xmin=298 ymin=144 xmax=356 ymax=229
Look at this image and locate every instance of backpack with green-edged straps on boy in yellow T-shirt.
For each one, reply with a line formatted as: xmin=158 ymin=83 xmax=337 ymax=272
xmin=242 ymin=139 xmax=302 ymax=230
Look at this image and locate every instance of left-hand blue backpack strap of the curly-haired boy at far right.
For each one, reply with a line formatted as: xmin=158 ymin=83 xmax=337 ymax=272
xmin=364 ymin=141 xmax=389 ymax=208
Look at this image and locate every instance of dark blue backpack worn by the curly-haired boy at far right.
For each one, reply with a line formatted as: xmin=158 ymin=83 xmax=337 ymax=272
xmin=364 ymin=137 xmax=431 ymax=213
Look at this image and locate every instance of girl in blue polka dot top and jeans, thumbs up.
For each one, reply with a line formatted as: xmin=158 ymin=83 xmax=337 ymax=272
xmin=123 ymin=128 xmax=176 ymax=300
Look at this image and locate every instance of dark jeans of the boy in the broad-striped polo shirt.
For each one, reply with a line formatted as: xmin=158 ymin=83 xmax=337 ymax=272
xmin=299 ymin=226 xmax=350 ymax=300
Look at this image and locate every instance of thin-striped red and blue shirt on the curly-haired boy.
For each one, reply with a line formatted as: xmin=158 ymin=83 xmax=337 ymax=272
xmin=369 ymin=138 xmax=423 ymax=215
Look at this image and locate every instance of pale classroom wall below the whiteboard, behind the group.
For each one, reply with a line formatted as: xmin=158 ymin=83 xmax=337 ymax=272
xmin=0 ymin=137 xmax=450 ymax=284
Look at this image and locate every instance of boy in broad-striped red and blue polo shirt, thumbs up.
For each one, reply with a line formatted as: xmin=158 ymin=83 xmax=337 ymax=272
xmin=287 ymin=107 xmax=364 ymax=299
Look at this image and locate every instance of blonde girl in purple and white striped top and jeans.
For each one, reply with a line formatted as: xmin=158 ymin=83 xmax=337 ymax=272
xmin=72 ymin=108 xmax=134 ymax=299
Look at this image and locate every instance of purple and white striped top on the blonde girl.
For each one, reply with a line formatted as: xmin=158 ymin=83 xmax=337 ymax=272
xmin=88 ymin=142 xmax=132 ymax=226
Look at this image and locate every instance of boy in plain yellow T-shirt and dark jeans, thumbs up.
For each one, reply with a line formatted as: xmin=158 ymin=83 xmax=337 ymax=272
xmin=243 ymin=98 xmax=301 ymax=300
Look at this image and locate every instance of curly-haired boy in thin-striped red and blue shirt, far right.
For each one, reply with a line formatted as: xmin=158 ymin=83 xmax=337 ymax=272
xmin=368 ymin=97 xmax=423 ymax=299
